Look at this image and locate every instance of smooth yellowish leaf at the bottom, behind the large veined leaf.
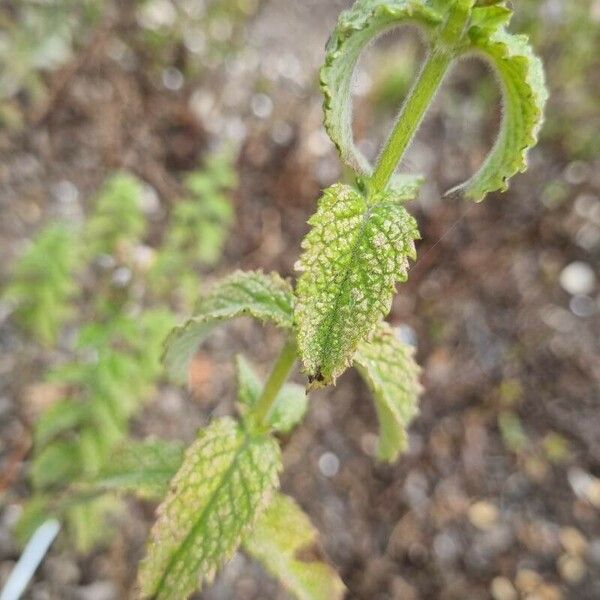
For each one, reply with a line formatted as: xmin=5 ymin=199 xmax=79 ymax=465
xmin=244 ymin=494 xmax=345 ymax=600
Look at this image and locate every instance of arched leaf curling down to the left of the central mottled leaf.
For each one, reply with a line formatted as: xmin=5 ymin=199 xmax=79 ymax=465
xmin=164 ymin=271 xmax=294 ymax=381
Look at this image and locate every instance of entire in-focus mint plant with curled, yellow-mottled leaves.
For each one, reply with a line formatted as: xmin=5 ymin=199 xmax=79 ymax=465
xmin=129 ymin=0 xmax=547 ymax=600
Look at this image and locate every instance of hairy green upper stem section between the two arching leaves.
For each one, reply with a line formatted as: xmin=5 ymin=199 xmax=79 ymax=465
xmin=370 ymin=0 xmax=473 ymax=192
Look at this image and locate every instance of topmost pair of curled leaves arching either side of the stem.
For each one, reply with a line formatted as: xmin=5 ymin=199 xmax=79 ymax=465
xmin=321 ymin=0 xmax=548 ymax=201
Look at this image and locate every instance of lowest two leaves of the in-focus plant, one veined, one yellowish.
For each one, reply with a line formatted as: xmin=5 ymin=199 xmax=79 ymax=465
xmin=139 ymin=417 xmax=344 ymax=600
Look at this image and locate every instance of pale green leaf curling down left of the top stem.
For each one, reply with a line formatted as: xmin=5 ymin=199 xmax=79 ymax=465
xmin=321 ymin=0 xmax=442 ymax=175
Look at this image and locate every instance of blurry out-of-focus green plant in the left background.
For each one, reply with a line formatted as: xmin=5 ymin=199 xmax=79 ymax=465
xmin=6 ymin=152 xmax=235 ymax=552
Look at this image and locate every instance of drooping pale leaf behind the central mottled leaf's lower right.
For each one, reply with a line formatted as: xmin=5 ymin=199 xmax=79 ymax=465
xmin=354 ymin=323 xmax=422 ymax=462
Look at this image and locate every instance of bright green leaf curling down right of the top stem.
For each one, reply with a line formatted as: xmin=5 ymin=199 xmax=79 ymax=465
xmin=449 ymin=6 xmax=548 ymax=201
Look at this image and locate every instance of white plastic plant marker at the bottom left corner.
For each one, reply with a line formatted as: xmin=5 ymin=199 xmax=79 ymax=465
xmin=0 ymin=519 xmax=60 ymax=600
